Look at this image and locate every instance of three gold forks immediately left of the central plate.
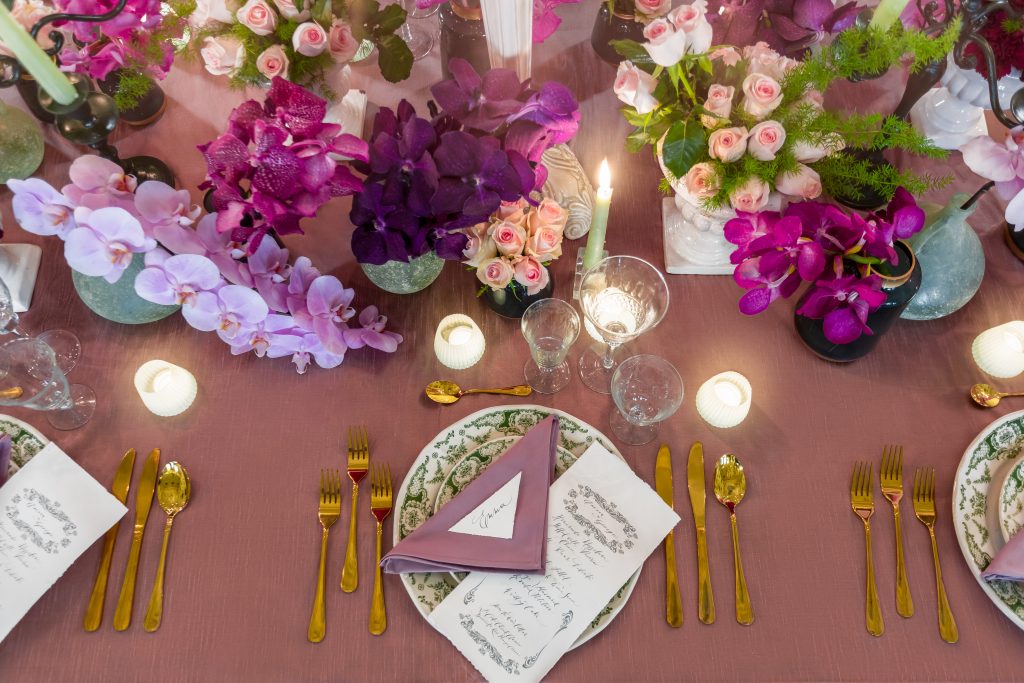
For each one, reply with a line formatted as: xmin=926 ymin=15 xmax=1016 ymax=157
xmin=306 ymin=427 xmax=392 ymax=643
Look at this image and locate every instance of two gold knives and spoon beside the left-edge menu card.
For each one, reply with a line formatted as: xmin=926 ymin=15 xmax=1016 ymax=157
xmin=83 ymin=449 xmax=191 ymax=633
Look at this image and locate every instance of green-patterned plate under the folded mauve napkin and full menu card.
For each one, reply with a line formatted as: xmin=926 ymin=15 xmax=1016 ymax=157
xmin=392 ymin=405 xmax=640 ymax=647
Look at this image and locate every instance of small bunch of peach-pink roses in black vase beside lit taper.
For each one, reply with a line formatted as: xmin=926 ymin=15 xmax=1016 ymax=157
xmin=463 ymin=199 xmax=568 ymax=317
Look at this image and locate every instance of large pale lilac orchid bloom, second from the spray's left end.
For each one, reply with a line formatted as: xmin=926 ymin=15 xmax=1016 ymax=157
xmin=65 ymin=207 xmax=157 ymax=283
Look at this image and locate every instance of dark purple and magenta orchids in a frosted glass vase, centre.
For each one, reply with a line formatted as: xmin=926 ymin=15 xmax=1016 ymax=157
xmin=350 ymin=59 xmax=580 ymax=293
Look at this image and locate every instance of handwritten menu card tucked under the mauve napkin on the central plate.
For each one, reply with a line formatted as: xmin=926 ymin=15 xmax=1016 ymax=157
xmin=428 ymin=443 xmax=679 ymax=683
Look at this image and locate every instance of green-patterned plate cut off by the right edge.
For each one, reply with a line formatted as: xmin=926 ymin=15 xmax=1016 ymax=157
xmin=952 ymin=411 xmax=1024 ymax=629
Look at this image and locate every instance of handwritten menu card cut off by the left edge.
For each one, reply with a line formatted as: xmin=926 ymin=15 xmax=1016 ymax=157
xmin=0 ymin=443 xmax=128 ymax=641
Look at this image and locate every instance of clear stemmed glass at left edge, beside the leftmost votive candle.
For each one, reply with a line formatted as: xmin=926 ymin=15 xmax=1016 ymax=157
xmin=0 ymin=337 xmax=96 ymax=430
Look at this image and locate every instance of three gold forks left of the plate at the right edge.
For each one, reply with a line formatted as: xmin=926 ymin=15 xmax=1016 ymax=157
xmin=850 ymin=445 xmax=959 ymax=643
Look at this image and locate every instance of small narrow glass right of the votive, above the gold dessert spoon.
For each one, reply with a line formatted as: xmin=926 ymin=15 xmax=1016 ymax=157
xmin=520 ymin=299 xmax=580 ymax=393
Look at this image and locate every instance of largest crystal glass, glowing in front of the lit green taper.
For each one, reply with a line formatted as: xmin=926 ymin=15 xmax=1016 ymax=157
xmin=580 ymin=256 xmax=669 ymax=393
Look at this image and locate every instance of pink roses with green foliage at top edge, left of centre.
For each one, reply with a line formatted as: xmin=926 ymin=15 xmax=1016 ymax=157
xmin=190 ymin=0 xmax=413 ymax=89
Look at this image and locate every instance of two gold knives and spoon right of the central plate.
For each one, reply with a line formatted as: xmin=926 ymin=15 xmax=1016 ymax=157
xmin=654 ymin=441 xmax=754 ymax=629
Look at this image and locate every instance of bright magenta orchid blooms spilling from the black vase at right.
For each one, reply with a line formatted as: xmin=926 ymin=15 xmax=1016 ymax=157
xmin=725 ymin=187 xmax=925 ymax=344
